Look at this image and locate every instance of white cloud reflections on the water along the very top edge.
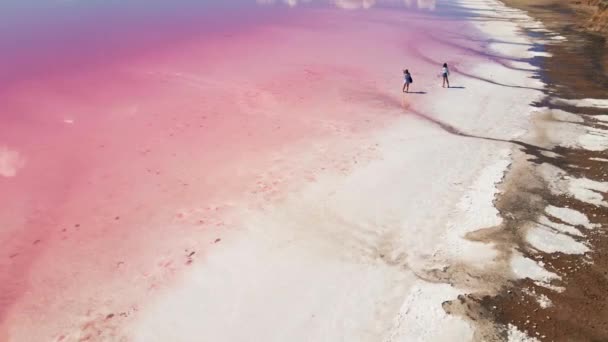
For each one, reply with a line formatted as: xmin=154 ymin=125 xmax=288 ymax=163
xmin=256 ymin=0 xmax=436 ymax=11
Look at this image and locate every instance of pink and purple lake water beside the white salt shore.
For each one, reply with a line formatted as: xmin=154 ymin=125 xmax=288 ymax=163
xmin=0 ymin=0 xmax=484 ymax=341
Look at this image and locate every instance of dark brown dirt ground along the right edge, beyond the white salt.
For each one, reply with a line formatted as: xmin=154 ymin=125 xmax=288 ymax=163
xmin=460 ymin=0 xmax=608 ymax=342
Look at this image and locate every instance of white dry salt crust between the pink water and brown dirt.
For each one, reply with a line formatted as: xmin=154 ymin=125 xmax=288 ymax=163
xmin=121 ymin=0 xmax=593 ymax=342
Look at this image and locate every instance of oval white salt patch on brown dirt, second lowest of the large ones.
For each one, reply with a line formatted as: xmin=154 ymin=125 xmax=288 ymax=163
xmin=526 ymin=226 xmax=589 ymax=254
